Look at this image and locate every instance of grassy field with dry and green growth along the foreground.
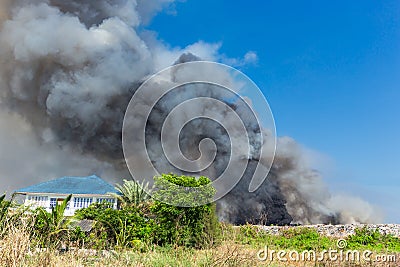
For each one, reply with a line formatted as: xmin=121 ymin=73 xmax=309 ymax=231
xmin=0 ymin=224 xmax=400 ymax=267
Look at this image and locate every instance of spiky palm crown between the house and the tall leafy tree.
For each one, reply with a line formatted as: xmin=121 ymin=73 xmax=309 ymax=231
xmin=115 ymin=179 xmax=151 ymax=207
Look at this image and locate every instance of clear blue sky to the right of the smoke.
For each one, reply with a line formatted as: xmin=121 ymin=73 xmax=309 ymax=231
xmin=146 ymin=0 xmax=400 ymax=223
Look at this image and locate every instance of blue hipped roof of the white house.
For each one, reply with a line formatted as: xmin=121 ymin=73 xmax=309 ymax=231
xmin=16 ymin=175 xmax=118 ymax=195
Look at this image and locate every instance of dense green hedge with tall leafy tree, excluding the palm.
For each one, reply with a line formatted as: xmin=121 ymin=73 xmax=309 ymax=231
xmin=72 ymin=174 xmax=219 ymax=248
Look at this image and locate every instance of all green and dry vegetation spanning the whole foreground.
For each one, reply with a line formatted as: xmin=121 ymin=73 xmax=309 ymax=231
xmin=0 ymin=177 xmax=400 ymax=266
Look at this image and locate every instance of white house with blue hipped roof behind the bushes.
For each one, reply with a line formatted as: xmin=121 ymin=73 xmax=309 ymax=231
xmin=15 ymin=175 xmax=119 ymax=216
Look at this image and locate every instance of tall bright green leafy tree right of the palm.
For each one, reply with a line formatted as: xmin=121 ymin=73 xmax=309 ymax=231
xmin=150 ymin=174 xmax=219 ymax=247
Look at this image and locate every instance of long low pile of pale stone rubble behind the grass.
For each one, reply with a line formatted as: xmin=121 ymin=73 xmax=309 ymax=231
xmin=259 ymin=224 xmax=400 ymax=238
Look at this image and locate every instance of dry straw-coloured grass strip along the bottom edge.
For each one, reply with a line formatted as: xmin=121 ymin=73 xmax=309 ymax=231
xmin=0 ymin=224 xmax=400 ymax=267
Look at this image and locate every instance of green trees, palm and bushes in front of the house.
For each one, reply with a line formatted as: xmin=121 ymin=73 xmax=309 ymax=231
xmin=0 ymin=174 xmax=220 ymax=254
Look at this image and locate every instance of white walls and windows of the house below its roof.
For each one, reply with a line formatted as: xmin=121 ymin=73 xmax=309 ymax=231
xmin=24 ymin=193 xmax=117 ymax=216
